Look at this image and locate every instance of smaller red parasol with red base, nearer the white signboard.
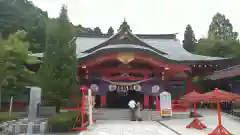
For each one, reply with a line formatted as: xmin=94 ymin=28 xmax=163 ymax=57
xmin=181 ymin=91 xmax=207 ymax=129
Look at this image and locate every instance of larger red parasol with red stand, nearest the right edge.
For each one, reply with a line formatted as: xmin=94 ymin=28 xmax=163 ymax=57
xmin=201 ymin=88 xmax=240 ymax=135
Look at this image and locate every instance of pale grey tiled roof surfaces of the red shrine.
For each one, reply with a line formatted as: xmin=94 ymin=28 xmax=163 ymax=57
xmin=76 ymin=37 xmax=223 ymax=61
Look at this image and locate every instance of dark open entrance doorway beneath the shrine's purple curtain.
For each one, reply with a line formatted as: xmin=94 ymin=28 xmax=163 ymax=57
xmin=107 ymin=90 xmax=143 ymax=108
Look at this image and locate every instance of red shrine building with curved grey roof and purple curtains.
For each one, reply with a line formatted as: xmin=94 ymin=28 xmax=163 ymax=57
xmin=72 ymin=20 xmax=240 ymax=108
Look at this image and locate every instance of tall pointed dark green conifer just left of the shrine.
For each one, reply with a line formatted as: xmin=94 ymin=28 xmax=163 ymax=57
xmin=38 ymin=6 xmax=77 ymax=112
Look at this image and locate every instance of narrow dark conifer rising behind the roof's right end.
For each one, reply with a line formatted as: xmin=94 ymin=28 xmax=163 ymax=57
xmin=183 ymin=24 xmax=196 ymax=52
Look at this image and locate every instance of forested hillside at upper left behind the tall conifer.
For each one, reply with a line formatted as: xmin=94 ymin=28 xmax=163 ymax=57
xmin=0 ymin=0 xmax=106 ymax=52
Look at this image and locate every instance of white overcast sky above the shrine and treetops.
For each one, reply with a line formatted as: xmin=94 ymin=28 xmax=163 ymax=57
xmin=31 ymin=0 xmax=240 ymax=39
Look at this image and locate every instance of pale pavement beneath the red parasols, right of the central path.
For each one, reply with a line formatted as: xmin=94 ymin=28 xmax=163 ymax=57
xmin=162 ymin=110 xmax=240 ymax=135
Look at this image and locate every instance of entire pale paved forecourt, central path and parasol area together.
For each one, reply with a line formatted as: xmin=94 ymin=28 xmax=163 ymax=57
xmin=0 ymin=110 xmax=240 ymax=135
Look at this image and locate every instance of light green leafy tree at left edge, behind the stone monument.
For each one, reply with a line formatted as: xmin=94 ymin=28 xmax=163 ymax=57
xmin=0 ymin=31 xmax=40 ymax=109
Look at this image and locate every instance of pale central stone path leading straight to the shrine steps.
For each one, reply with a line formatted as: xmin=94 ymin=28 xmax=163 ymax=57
xmin=79 ymin=121 xmax=176 ymax=135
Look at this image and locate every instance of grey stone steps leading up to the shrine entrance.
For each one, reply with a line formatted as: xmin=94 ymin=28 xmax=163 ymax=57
xmin=93 ymin=108 xmax=189 ymax=121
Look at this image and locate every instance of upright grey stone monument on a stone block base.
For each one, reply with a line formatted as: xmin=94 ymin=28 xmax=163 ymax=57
xmin=15 ymin=87 xmax=47 ymax=135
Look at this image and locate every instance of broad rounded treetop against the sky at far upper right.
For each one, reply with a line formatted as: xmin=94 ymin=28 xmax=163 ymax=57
xmin=208 ymin=13 xmax=238 ymax=40
